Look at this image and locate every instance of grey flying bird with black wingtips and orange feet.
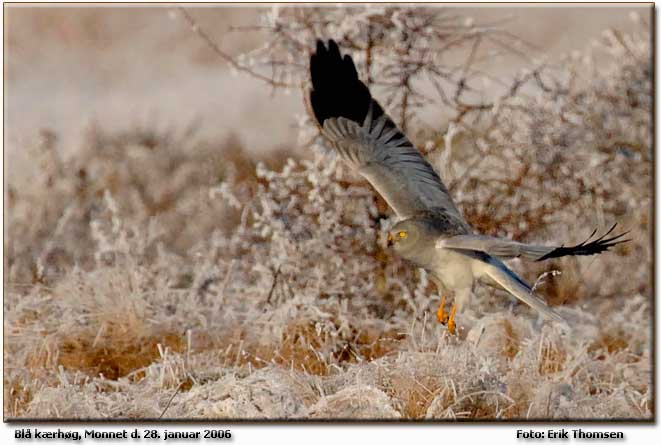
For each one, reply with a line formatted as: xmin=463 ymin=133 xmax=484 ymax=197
xmin=310 ymin=40 xmax=628 ymax=333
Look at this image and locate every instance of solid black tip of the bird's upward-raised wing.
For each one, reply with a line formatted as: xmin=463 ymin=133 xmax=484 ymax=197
xmin=310 ymin=39 xmax=374 ymax=126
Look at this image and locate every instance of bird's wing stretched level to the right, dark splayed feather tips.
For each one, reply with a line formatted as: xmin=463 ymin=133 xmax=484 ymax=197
xmin=436 ymin=224 xmax=629 ymax=261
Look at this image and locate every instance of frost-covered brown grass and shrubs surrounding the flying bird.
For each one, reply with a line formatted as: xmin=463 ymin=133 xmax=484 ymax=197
xmin=4 ymin=8 xmax=654 ymax=419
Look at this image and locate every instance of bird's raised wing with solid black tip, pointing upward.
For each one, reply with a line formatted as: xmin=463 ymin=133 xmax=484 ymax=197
xmin=310 ymin=40 xmax=470 ymax=229
